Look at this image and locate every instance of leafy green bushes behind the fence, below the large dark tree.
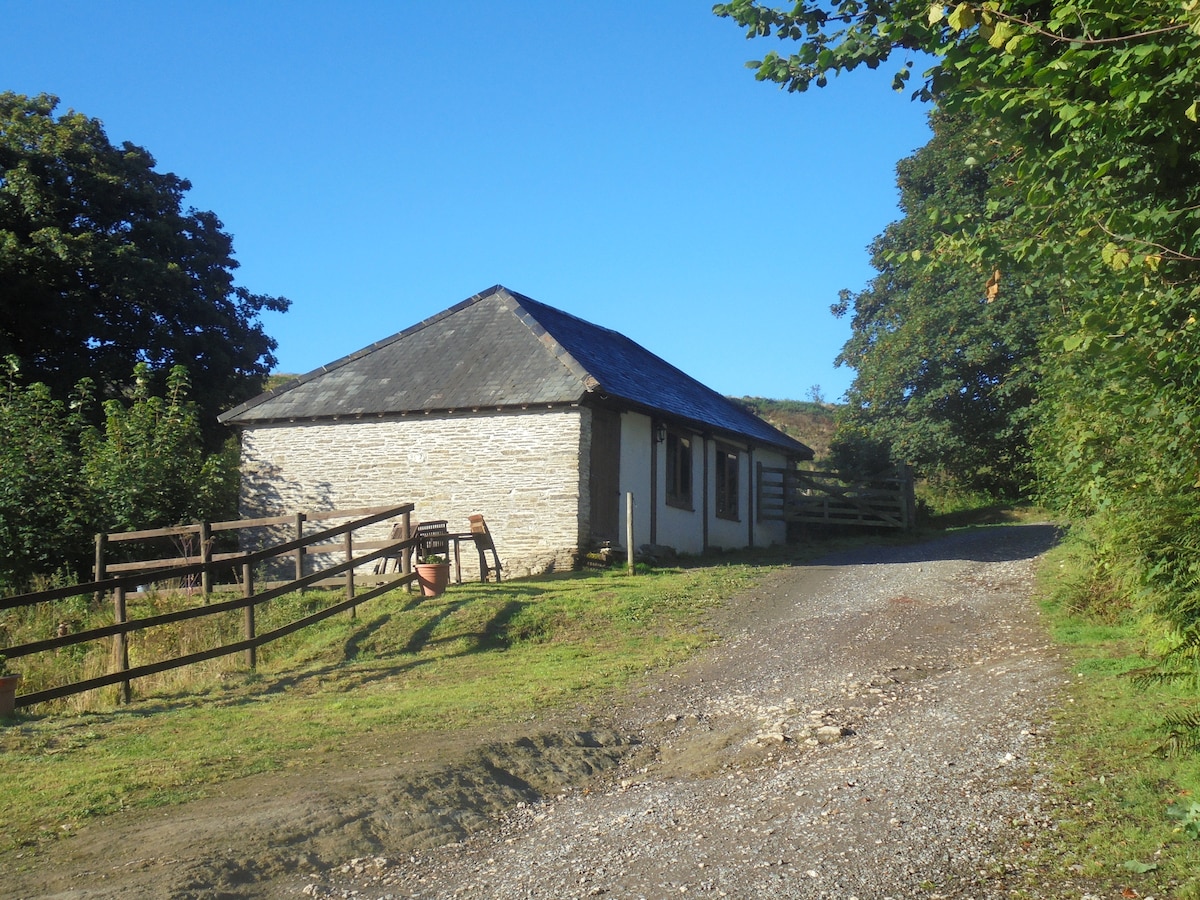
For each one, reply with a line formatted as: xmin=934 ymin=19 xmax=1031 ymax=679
xmin=0 ymin=356 xmax=239 ymax=594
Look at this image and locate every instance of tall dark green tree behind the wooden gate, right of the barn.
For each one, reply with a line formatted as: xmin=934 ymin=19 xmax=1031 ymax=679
xmin=833 ymin=112 xmax=1049 ymax=496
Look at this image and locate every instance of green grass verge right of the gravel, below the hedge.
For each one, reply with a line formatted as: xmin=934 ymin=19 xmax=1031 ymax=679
xmin=1038 ymin=546 xmax=1200 ymax=900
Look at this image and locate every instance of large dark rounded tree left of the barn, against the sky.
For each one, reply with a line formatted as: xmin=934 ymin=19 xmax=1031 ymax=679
xmin=0 ymin=92 xmax=289 ymax=433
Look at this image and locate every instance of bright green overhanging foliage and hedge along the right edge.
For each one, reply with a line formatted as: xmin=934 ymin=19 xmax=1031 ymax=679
xmin=714 ymin=0 xmax=1200 ymax=629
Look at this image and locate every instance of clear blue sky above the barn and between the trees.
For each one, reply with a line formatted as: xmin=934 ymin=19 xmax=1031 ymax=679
xmin=0 ymin=0 xmax=928 ymax=400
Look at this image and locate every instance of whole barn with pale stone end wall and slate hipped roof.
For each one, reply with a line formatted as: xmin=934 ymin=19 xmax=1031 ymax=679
xmin=221 ymin=286 xmax=812 ymax=575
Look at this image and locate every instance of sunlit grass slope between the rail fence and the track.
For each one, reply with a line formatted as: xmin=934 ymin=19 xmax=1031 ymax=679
xmin=0 ymin=563 xmax=763 ymax=853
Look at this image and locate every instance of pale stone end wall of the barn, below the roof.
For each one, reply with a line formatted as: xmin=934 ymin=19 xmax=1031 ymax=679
xmin=241 ymin=408 xmax=588 ymax=578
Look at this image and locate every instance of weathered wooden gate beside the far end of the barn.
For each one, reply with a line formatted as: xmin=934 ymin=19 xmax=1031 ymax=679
xmin=757 ymin=463 xmax=916 ymax=528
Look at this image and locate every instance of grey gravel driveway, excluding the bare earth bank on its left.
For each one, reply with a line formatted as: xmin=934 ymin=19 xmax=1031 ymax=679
xmin=307 ymin=526 xmax=1064 ymax=900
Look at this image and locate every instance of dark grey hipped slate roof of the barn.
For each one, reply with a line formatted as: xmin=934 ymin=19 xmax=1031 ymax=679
xmin=221 ymin=284 xmax=812 ymax=458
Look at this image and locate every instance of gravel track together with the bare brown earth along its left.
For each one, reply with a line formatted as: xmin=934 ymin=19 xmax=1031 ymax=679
xmin=7 ymin=526 xmax=1063 ymax=900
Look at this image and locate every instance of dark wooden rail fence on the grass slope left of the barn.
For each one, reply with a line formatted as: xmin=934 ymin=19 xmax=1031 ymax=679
xmin=0 ymin=503 xmax=416 ymax=707
